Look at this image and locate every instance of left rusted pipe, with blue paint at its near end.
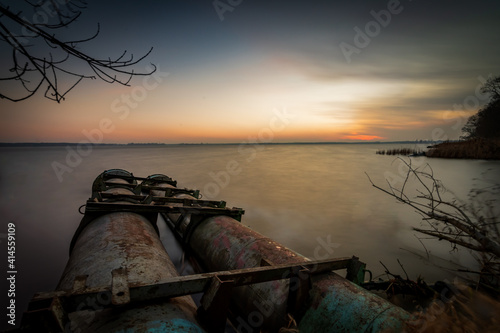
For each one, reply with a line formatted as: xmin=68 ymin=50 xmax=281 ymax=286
xmin=49 ymin=169 xmax=203 ymax=332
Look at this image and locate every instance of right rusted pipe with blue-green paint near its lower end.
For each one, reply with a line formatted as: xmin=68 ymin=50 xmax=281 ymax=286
xmin=150 ymin=175 xmax=409 ymax=332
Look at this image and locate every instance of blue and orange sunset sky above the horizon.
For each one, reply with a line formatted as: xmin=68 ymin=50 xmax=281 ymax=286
xmin=0 ymin=0 xmax=500 ymax=143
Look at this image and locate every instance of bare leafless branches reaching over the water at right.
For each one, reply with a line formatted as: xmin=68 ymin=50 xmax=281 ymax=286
xmin=367 ymin=158 xmax=500 ymax=292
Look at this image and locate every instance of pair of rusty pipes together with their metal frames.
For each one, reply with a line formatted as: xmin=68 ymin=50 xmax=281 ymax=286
xmin=19 ymin=169 xmax=409 ymax=332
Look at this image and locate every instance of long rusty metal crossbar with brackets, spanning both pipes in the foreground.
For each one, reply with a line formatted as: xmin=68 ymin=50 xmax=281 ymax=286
xmin=26 ymin=257 xmax=358 ymax=332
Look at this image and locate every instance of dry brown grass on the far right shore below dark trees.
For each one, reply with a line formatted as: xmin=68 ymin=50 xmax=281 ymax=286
xmin=426 ymin=139 xmax=500 ymax=159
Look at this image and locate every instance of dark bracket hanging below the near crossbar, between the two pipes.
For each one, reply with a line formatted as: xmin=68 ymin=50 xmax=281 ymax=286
xmin=198 ymin=276 xmax=234 ymax=332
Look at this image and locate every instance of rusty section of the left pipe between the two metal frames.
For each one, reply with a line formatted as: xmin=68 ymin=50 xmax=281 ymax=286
xmin=57 ymin=212 xmax=179 ymax=290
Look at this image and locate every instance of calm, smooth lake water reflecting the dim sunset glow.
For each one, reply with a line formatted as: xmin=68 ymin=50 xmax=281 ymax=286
xmin=0 ymin=144 xmax=500 ymax=321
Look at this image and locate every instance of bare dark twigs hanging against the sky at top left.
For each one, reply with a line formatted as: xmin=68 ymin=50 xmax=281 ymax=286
xmin=0 ymin=0 xmax=156 ymax=103
